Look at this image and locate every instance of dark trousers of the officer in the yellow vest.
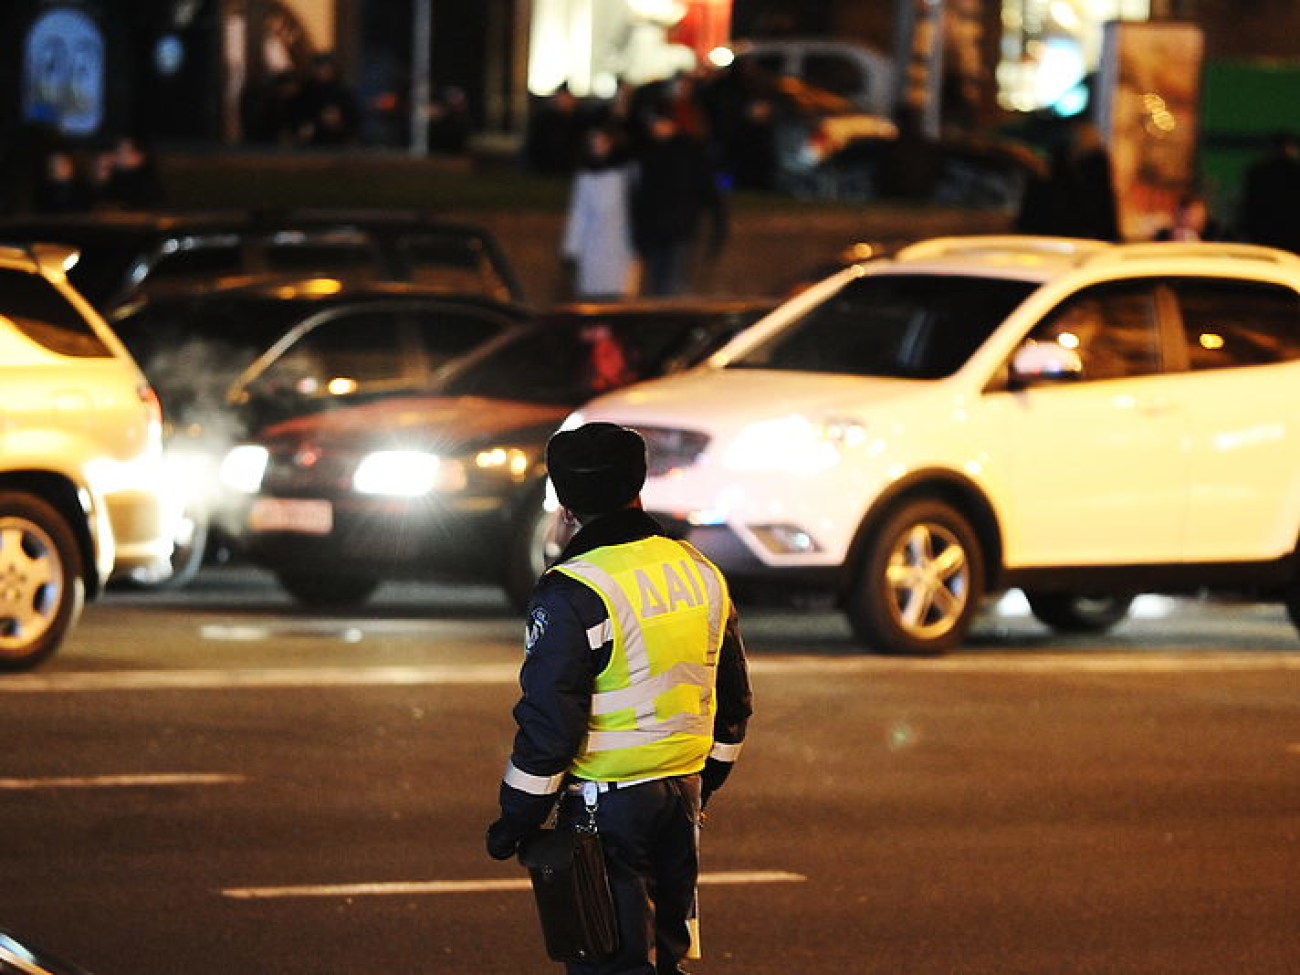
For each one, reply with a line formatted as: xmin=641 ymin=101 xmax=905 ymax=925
xmin=559 ymin=775 xmax=699 ymax=975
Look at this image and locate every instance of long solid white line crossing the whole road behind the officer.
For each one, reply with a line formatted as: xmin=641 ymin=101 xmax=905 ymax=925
xmin=0 ymin=651 xmax=1300 ymax=694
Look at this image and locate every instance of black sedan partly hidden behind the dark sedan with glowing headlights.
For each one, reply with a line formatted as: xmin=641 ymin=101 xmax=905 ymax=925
xmin=112 ymin=277 xmax=527 ymax=586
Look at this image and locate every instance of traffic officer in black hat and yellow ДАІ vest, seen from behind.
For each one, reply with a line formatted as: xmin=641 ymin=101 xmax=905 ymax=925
xmin=488 ymin=423 xmax=751 ymax=975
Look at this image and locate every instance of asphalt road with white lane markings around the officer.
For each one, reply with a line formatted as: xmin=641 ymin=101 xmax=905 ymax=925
xmin=0 ymin=571 xmax=1300 ymax=975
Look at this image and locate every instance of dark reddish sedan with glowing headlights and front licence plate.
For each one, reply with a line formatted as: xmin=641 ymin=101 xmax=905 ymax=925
xmin=224 ymin=302 xmax=771 ymax=607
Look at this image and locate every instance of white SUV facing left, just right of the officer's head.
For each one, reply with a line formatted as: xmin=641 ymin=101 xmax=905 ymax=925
xmin=571 ymin=237 xmax=1300 ymax=653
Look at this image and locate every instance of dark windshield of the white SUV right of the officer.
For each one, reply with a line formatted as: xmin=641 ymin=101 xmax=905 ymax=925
xmin=728 ymin=274 xmax=1037 ymax=380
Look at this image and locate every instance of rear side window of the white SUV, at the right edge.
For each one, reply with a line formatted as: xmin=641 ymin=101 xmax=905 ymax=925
xmin=1169 ymin=278 xmax=1300 ymax=369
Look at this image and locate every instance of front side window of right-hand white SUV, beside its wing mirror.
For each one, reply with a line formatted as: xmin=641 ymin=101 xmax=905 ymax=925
xmin=1030 ymin=282 xmax=1161 ymax=381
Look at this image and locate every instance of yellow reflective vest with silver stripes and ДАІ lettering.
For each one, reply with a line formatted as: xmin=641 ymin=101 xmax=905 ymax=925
xmin=554 ymin=536 xmax=729 ymax=781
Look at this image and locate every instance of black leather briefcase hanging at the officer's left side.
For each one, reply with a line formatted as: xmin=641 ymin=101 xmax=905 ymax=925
xmin=519 ymin=829 xmax=619 ymax=962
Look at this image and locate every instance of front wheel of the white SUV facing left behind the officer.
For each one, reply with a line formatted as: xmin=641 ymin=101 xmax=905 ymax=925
xmin=845 ymin=498 xmax=984 ymax=655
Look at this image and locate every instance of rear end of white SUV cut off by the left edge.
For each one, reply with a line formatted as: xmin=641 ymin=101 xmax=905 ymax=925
xmin=0 ymin=244 xmax=170 ymax=671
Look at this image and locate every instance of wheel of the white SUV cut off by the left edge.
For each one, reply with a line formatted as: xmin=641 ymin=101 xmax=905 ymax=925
xmin=0 ymin=491 xmax=86 ymax=671
